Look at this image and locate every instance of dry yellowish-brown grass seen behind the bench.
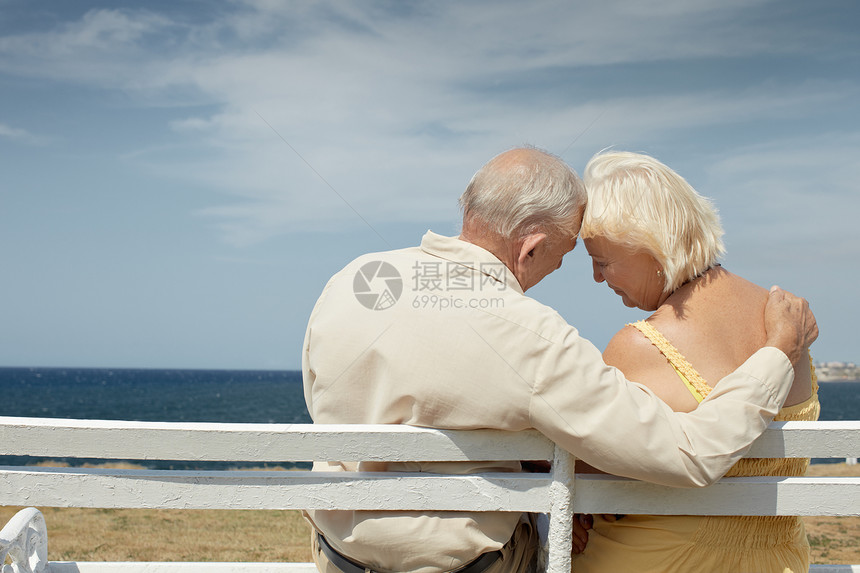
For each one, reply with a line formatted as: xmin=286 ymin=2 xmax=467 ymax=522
xmin=0 ymin=464 xmax=860 ymax=563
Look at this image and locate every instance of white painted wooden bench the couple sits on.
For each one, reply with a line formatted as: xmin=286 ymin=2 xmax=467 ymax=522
xmin=0 ymin=417 xmax=860 ymax=573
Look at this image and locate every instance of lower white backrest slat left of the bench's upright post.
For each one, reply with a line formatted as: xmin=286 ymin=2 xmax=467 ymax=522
xmin=0 ymin=467 xmax=551 ymax=512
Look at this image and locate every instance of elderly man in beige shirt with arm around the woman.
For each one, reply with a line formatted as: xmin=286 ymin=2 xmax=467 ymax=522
xmin=302 ymin=149 xmax=817 ymax=573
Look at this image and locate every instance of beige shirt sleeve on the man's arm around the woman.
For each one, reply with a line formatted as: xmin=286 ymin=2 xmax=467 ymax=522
xmin=530 ymin=330 xmax=794 ymax=487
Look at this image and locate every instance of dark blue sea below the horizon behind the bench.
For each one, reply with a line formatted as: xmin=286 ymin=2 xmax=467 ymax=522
xmin=0 ymin=368 xmax=860 ymax=469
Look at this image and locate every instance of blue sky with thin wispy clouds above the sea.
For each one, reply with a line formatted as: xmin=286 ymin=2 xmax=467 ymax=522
xmin=0 ymin=0 xmax=860 ymax=369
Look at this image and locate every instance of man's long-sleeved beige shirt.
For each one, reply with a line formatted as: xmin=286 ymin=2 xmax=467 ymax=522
xmin=302 ymin=232 xmax=794 ymax=573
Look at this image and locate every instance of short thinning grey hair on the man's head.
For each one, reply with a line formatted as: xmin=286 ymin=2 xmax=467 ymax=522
xmin=460 ymin=148 xmax=586 ymax=239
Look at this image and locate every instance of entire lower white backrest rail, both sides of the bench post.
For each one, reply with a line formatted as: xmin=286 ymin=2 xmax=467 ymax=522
xmin=0 ymin=468 xmax=860 ymax=515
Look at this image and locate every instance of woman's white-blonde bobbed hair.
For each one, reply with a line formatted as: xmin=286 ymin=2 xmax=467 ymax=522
xmin=580 ymin=151 xmax=725 ymax=292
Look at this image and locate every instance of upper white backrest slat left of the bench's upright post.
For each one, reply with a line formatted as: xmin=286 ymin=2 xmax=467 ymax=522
xmin=0 ymin=417 xmax=555 ymax=462
